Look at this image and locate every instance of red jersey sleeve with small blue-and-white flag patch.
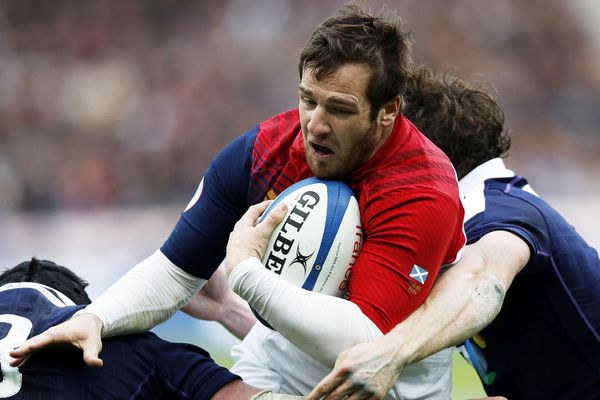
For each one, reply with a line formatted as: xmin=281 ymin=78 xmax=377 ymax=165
xmin=349 ymin=191 xmax=465 ymax=334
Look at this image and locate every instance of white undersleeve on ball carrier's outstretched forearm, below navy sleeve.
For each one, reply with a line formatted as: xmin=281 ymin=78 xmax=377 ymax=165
xmin=78 ymin=250 xmax=206 ymax=337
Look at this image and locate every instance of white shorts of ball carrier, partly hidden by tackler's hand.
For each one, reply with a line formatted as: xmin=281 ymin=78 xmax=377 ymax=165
xmin=231 ymin=322 xmax=452 ymax=400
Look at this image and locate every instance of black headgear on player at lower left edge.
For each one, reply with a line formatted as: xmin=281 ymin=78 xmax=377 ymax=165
xmin=0 ymin=257 xmax=92 ymax=304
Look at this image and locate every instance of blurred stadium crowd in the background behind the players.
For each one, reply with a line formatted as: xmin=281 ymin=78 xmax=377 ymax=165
xmin=0 ymin=0 xmax=600 ymax=212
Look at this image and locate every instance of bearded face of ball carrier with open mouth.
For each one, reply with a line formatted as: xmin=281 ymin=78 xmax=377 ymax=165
xmin=299 ymin=64 xmax=391 ymax=179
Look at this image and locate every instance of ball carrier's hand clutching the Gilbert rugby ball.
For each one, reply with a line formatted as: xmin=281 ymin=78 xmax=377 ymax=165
xmin=225 ymin=200 xmax=287 ymax=277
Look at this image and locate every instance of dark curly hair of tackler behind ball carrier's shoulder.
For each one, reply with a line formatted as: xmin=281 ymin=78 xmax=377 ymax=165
xmin=403 ymin=67 xmax=510 ymax=179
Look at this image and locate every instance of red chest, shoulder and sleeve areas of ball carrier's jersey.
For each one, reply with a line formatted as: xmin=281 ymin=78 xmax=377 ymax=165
xmin=249 ymin=109 xmax=465 ymax=333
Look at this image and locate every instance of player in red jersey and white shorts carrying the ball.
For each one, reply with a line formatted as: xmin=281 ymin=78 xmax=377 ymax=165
xmin=12 ymin=6 xmax=465 ymax=399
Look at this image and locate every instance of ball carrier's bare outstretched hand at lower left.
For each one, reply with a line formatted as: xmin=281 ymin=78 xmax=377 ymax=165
xmin=10 ymin=313 xmax=103 ymax=368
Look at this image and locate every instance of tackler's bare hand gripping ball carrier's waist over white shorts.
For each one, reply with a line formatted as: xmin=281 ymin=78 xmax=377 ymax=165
xmin=306 ymin=336 xmax=404 ymax=400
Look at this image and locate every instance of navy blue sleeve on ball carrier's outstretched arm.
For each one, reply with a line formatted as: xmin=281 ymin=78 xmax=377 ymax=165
xmin=160 ymin=125 xmax=259 ymax=279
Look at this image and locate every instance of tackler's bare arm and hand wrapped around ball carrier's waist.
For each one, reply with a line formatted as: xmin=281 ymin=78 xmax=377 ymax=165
xmin=307 ymin=231 xmax=530 ymax=400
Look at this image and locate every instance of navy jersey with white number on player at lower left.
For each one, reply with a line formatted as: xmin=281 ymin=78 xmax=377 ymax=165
xmin=0 ymin=283 xmax=239 ymax=400
